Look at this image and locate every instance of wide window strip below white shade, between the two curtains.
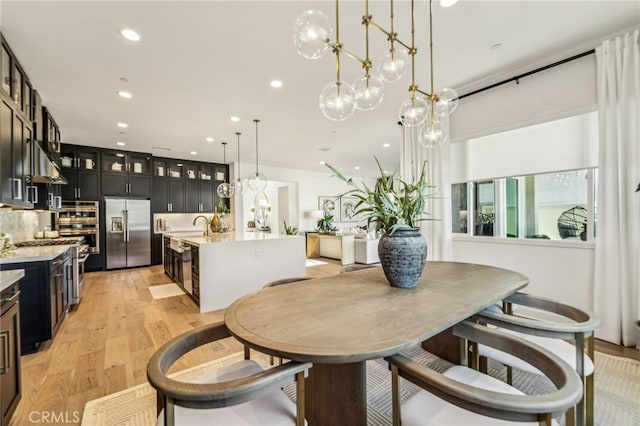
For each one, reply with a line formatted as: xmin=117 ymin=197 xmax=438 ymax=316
xmin=452 ymin=169 xmax=597 ymax=241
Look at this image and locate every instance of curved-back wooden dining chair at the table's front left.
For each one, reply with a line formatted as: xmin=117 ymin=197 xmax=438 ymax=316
xmin=147 ymin=322 xmax=312 ymax=426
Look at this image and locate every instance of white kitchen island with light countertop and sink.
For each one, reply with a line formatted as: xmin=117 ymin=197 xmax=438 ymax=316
xmin=164 ymin=231 xmax=306 ymax=312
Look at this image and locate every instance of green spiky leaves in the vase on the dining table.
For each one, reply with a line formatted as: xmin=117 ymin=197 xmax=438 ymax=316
xmin=327 ymin=156 xmax=433 ymax=234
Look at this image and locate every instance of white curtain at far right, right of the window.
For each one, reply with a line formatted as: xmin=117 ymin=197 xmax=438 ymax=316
xmin=594 ymin=30 xmax=640 ymax=346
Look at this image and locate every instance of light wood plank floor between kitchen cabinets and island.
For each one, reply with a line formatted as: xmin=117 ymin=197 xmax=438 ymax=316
xmin=11 ymin=259 xmax=640 ymax=426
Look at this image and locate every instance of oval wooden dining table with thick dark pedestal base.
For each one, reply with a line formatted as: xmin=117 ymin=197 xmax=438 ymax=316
xmin=225 ymin=261 xmax=528 ymax=426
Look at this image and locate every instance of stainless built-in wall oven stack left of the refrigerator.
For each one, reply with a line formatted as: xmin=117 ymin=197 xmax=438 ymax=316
xmin=56 ymin=201 xmax=100 ymax=254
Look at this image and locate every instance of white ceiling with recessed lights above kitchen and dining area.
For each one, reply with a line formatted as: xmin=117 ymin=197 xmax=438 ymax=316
xmin=0 ymin=0 xmax=640 ymax=176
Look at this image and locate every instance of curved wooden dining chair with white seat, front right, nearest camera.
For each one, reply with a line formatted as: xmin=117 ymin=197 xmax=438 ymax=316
xmin=385 ymin=321 xmax=582 ymax=426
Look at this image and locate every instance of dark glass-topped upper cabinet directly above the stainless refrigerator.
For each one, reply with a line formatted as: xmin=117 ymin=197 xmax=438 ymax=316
xmin=101 ymin=150 xmax=152 ymax=197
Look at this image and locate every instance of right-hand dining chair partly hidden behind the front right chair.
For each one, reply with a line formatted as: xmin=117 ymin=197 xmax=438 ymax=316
xmin=477 ymin=293 xmax=600 ymax=426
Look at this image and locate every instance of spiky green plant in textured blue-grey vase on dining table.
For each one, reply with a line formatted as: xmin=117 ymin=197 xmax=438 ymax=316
xmin=327 ymin=157 xmax=432 ymax=288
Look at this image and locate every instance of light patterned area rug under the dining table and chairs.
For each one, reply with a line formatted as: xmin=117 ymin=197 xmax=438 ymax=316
xmin=82 ymin=348 xmax=640 ymax=426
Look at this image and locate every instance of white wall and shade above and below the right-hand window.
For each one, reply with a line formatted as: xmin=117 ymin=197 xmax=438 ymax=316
xmin=451 ymin=49 xmax=598 ymax=310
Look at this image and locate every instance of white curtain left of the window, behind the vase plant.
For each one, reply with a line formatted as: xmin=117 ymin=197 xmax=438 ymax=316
xmin=400 ymin=124 xmax=452 ymax=260
